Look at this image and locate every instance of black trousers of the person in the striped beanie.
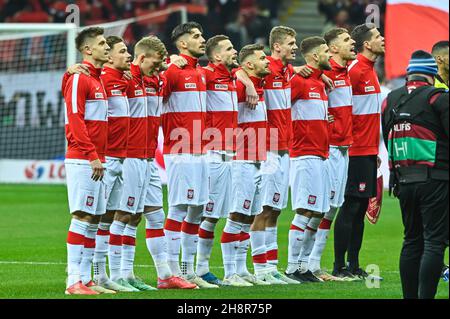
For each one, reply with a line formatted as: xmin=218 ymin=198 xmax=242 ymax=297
xmin=398 ymin=180 xmax=449 ymax=299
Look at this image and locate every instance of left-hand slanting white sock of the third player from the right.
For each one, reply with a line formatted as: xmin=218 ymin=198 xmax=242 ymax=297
xmin=286 ymin=214 xmax=310 ymax=274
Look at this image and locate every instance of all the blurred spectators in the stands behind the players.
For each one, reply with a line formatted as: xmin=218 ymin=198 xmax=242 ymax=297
xmin=0 ymin=0 xmax=386 ymax=76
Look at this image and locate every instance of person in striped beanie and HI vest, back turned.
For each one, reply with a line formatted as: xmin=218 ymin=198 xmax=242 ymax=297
xmin=382 ymin=51 xmax=449 ymax=299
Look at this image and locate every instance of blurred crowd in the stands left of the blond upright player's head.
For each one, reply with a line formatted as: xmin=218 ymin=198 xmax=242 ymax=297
xmin=0 ymin=0 xmax=281 ymax=48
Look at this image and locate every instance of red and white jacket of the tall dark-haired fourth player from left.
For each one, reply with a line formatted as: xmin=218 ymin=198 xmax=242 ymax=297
xmin=161 ymin=54 xmax=206 ymax=154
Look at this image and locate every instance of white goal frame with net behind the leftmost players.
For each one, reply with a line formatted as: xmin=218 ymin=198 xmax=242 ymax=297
xmin=0 ymin=6 xmax=187 ymax=183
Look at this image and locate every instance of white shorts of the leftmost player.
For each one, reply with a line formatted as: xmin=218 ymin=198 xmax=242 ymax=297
xmin=65 ymin=160 xmax=106 ymax=215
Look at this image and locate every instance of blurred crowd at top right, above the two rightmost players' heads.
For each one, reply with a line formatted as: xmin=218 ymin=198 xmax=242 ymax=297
xmin=318 ymin=0 xmax=386 ymax=34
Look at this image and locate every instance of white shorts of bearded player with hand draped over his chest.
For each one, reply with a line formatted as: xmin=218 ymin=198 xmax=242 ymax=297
xmin=230 ymin=161 xmax=262 ymax=216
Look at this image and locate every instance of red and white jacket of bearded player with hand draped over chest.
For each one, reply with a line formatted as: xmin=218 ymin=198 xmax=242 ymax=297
xmin=234 ymin=76 xmax=267 ymax=162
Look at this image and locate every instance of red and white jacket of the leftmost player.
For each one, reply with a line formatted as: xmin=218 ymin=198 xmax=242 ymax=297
xmin=62 ymin=61 xmax=108 ymax=163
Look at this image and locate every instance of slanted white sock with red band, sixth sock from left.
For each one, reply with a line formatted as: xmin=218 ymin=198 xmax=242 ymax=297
xmin=144 ymin=208 xmax=172 ymax=279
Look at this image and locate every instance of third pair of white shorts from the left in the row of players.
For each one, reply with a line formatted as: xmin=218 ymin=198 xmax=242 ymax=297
xmin=119 ymin=158 xmax=148 ymax=214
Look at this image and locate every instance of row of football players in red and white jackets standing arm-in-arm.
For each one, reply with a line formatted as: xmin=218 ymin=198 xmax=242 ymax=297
xmin=62 ymin=23 xmax=384 ymax=294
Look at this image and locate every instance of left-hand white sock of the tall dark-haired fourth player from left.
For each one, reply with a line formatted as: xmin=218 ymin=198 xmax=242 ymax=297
xmin=164 ymin=205 xmax=187 ymax=276
